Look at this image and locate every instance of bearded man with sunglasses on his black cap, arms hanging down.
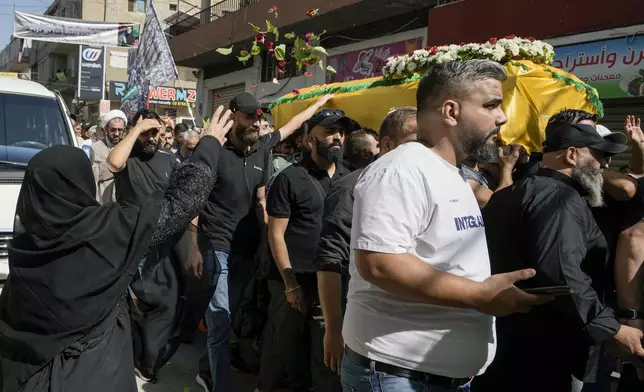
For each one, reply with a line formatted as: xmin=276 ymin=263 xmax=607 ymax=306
xmin=259 ymin=109 xmax=353 ymax=392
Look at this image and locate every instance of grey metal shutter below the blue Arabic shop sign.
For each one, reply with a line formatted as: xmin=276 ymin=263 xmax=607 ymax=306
xmin=599 ymin=97 xmax=644 ymax=169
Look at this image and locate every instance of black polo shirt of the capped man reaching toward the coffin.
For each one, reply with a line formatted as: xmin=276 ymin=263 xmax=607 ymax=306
xmin=199 ymin=131 xmax=281 ymax=255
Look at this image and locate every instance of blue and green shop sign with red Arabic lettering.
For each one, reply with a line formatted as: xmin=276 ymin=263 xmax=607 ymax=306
xmin=552 ymin=36 xmax=644 ymax=99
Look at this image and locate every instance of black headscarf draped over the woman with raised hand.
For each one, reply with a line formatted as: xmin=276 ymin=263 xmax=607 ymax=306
xmin=0 ymin=146 xmax=163 ymax=376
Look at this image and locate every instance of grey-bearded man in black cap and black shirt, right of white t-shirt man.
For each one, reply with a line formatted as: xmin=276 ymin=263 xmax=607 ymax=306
xmin=473 ymin=120 xmax=644 ymax=392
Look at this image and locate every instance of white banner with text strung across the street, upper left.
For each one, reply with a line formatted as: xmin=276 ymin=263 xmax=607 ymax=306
xmin=13 ymin=11 xmax=141 ymax=47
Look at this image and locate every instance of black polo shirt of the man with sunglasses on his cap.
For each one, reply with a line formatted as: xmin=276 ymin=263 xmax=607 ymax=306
xmin=266 ymin=156 xmax=349 ymax=278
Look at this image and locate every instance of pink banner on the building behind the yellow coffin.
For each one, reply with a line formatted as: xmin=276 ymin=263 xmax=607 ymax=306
xmin=327 ymin=37 xmax=423 ymax=83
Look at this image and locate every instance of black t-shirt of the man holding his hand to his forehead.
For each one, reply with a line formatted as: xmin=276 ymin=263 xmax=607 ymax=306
xmin=114 ymin=150 xmax=177 ymax=205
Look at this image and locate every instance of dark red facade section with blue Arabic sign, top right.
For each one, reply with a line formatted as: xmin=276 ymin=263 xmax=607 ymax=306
xmin=427 ymin=0 xmax=644 ymax=167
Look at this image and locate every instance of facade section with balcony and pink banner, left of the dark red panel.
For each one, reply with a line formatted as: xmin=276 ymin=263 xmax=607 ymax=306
xmin=170 ymin=0 xmax=436 ymax=121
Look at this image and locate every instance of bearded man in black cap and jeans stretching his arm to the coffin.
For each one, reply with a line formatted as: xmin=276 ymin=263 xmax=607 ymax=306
xmin=189 ymin=93 xmax=332 ymax=392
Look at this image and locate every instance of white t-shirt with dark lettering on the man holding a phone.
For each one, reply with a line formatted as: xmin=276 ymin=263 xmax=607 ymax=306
xmin=342 ymin=142 xmax=496 ymax=378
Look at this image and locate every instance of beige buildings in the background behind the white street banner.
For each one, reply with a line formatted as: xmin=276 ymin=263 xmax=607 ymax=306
xmin=0 ymin=0 xmax=201 ymax=124
